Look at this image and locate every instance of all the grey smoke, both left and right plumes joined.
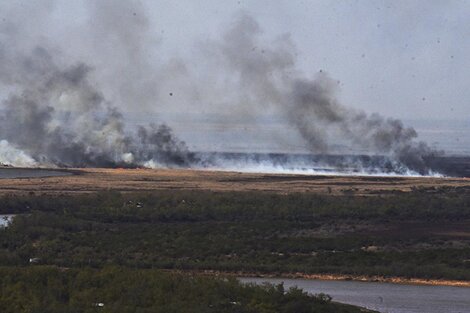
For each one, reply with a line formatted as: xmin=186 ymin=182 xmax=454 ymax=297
xmin=0 ymin=1 xmax=441 ymax=174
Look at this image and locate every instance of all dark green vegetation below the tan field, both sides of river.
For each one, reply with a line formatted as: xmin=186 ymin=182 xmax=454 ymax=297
xmin=0 ymin=190 xmax=470 ymax=313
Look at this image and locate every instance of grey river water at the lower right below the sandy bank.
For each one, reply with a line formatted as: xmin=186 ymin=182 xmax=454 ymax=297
xmin=240 ymin=278 xmax=470 ymax=313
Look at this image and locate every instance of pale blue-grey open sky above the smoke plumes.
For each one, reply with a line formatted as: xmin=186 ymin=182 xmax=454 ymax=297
xmin=0 ymin=0 xmax=470 ymax=119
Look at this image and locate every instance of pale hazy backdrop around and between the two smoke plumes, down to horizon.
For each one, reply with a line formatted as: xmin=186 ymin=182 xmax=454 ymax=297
xmin=0 ymin=0 xmax=470 ymax=154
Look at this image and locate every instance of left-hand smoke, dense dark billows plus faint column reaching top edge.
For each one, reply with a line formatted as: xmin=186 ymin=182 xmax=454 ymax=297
xmin=0 ymin=1 xmax=196 ymax=167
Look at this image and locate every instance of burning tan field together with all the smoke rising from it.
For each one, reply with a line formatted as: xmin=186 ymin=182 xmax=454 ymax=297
xmin=0 ymin=1 xmax=470 ymax=195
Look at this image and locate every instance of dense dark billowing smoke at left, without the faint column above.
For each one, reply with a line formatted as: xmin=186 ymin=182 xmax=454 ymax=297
xmin=0 ymin=48 xmax=195 ymax=167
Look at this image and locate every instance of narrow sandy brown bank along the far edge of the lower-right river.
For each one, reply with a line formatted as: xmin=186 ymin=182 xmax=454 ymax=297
xmin=179 ymin=270 xmax=470 ymax=288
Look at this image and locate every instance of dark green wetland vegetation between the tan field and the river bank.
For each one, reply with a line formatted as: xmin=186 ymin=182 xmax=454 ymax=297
xmin=0 ymin=191 xmax=470 ymax=280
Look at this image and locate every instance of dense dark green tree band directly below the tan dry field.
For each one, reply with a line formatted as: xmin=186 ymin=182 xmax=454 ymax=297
xmin=0 ymin=189 xmax=470 ymax=222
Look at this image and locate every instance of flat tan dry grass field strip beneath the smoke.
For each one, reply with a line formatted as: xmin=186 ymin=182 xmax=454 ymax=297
xmin=0 ymin=168 xmax=470 ymax=195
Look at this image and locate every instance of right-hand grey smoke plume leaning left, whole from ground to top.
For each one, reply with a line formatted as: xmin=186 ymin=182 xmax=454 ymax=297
xmin=216 ymin=14 xmax=442 ymax=174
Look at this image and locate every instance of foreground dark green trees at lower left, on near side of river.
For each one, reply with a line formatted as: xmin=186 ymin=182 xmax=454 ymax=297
xmin=0 ymin=266 xmax=364 ymax=313
